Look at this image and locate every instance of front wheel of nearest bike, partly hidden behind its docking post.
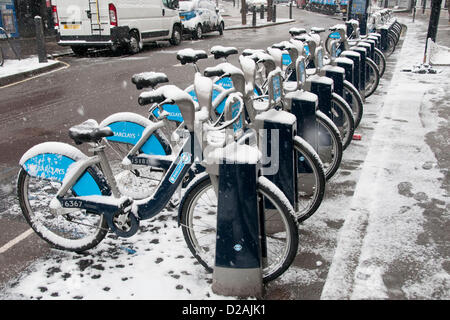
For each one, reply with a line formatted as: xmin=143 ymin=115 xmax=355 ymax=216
xmin=180 ymin=176 xmax=298 ymax=282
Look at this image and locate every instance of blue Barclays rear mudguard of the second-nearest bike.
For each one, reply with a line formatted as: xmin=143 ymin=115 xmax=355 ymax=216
xmin=100 ymin=112 xmax=171 ymax=156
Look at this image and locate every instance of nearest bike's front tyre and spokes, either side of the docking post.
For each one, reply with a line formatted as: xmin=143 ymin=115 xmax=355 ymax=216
xmin=179 ymin=175 xmax=298 ymax=283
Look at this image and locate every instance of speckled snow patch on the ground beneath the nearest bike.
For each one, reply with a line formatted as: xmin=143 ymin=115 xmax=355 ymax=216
xmin=0 ymin=211 xmax=232 ymax=300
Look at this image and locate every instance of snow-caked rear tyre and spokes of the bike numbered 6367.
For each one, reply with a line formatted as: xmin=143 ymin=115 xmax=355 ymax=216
xmin=17 ymin=168 xmax=109 ymax=252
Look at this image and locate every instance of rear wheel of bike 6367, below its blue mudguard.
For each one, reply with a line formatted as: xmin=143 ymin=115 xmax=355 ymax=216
xmin=17 ymin=168 xmax=108 ymax=252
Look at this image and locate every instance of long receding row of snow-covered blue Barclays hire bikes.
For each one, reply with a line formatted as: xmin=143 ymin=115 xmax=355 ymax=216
xmin=17 ymin=11 xmax=404 ymax=282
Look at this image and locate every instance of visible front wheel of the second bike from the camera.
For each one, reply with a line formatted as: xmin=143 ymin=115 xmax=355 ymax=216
xmin=293 ymin=136 xmax=326 ymax=222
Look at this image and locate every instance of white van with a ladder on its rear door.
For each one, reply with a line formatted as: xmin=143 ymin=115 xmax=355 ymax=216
xmin=52 ymin=0 xmax=182 ymax=55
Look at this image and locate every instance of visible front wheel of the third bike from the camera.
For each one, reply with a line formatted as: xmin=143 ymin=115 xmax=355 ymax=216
xmin=316 ymin=111 xmax=344 ymax=181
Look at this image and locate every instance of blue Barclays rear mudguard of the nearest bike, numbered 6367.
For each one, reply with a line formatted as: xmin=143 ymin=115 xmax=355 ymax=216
xmin=19 ymin=142 xmax=110 ymax=196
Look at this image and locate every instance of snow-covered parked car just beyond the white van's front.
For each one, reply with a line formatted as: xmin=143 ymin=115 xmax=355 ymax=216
xmin=179 ymin=0 xmax=225 ymax=39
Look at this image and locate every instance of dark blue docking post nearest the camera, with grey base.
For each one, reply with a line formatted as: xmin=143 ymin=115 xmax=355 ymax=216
xmin=212 ymin=161 xmax=263 ymax=297
